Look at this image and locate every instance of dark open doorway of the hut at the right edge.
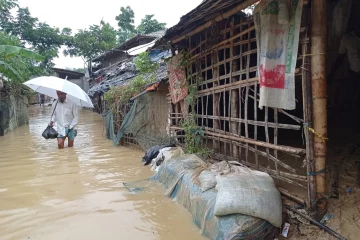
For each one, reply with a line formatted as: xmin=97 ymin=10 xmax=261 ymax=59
xmin=327 ymin=1 xmax=360 ymax=201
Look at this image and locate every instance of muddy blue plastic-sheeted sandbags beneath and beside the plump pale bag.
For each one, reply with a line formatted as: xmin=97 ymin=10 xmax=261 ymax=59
xmin=151 ymin=154 xmax=279 ymax=240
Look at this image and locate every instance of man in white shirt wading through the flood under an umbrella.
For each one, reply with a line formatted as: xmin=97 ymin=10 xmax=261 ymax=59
xmin=50 ymin=91 xmax=79 ymax=149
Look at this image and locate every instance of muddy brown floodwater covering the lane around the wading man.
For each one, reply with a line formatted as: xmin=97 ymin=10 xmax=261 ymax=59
xmin=0 ymin=107 xmax=204 ymax=240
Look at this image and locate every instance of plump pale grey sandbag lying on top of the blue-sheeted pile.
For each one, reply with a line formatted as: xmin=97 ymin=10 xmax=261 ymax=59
xmin=214 ymin=172 xmax=282 ymax=227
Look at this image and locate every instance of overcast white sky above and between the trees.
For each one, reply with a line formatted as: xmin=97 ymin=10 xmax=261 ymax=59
xmin=18 ymin=0 xmax=202 ymax=68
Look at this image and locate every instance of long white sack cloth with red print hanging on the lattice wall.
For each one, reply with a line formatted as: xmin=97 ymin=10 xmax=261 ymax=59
xmin=254 ymin=0 xmax=303 ymax=110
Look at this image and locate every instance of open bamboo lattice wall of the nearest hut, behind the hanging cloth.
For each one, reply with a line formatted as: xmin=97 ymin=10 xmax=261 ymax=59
xmin=170 ymin=3 xmax=314 ymax=206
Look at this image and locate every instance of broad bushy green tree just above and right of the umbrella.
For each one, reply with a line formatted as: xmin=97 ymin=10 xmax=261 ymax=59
xmin=64 ymin=21 xmax=117 ymax=64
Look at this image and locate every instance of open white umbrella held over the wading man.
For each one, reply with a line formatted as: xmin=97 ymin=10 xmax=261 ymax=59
xmin=24 ymin=76 xmax=94 ymax=108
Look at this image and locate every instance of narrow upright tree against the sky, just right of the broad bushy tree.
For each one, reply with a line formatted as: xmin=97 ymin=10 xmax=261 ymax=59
xmin=115 ymin=6 xmax=136 ymax=44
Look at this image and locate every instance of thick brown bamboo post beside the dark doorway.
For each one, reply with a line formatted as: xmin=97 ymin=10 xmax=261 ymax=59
xmin=310 ymin=0 xmax=327 ymax=216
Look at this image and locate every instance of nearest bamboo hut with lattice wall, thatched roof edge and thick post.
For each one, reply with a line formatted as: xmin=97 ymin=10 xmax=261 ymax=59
xmin=155 ymin=0 xmax=334 ymax=218
